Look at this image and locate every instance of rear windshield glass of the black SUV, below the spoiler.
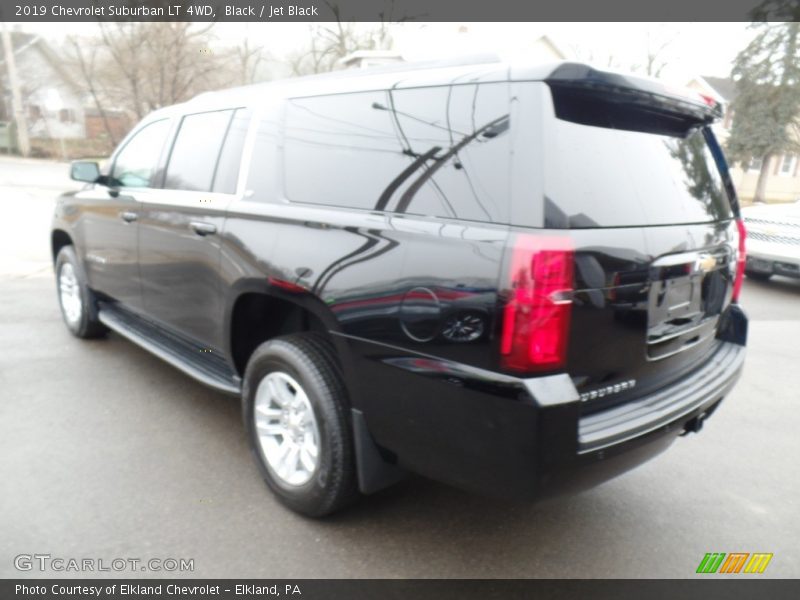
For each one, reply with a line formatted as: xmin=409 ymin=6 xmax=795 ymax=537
xmin=543 ymin=99 xmax=732 ymax=229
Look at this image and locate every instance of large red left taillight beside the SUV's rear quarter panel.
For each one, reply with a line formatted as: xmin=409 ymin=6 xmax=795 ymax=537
xmin=500 ymin=235 xmax=575 ymax=371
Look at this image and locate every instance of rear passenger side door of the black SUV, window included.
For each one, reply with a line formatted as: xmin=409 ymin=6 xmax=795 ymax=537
xmin=139 ymin=108 xmax=250 ymax=349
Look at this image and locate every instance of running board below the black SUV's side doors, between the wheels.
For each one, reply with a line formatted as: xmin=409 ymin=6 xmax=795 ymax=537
xmin=98 ymin=302 xmax=242 ymax=396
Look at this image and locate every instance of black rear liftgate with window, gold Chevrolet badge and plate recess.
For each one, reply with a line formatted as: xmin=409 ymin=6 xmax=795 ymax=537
xmin=515 ymin=78 xmax=738 ymax=409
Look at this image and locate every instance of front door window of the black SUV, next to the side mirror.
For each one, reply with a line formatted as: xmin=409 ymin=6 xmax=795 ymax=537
xmin=111 ymin=119 xmax=169 ymax=187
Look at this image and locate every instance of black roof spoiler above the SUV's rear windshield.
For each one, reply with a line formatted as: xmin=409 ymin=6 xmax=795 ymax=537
xmin=545 ymin=63 xmax=722 ymax=129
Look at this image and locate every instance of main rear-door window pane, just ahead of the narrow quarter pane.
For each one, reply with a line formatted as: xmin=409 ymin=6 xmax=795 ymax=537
xmin=164 ymin=110 xmax=234 ymax=192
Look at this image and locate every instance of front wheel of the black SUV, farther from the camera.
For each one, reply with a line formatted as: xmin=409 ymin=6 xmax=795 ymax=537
xmin=56 ymin=246 xmax=108 ymax=339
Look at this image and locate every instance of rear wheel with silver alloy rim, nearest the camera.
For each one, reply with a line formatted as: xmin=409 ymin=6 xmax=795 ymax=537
xmin=242 ymin=333 xmax=359 ymax=517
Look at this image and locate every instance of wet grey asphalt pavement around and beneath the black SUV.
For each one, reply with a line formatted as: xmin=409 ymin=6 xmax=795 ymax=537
xmin=0 ymin=158 xmax=800 ymax=578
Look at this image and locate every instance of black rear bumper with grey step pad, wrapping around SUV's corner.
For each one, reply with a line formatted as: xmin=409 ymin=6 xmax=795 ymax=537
xmin=346 ymin=306 xmax=747 ymax=499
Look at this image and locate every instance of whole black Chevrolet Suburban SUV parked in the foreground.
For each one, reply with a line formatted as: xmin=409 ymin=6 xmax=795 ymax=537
xmin=52 ymin=63 xmax=747 ymax=516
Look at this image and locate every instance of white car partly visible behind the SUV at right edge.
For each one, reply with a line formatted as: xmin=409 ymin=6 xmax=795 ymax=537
xmin=742 ymin=200 xmax=800 ymax=281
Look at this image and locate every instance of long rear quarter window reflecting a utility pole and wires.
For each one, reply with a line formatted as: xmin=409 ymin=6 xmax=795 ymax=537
xmin=284 ymin=83 xmax=510 ymax=223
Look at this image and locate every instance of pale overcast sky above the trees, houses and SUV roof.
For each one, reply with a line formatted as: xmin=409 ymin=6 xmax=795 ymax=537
xmin=9 ymin=23 xmax=752 ymax=84
